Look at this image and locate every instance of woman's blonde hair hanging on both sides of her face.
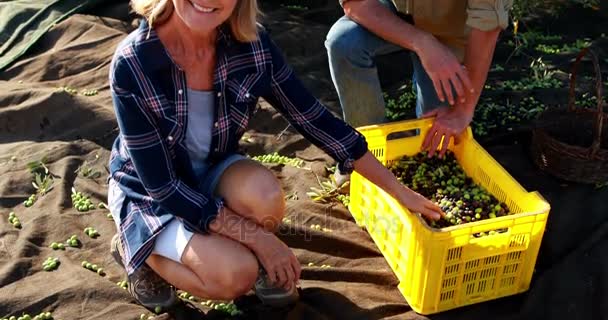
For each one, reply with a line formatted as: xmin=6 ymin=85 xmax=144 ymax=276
xmin=131 ymin=0 xmax=261 ymax=42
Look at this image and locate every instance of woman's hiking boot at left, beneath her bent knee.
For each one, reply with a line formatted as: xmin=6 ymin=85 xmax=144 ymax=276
xmin=110 ymin=234 xmax=178 ymax=310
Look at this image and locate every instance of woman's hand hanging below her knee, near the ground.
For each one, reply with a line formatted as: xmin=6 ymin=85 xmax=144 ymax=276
xmin=250 ymin=232 xmax=301 ymax=290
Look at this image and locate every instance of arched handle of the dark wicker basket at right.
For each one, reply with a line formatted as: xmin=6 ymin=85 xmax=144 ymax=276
xmin=568 ymin=47 xmax=604 ymax=157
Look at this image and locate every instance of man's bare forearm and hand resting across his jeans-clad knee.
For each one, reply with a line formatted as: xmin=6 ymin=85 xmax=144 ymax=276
xmin=342 ymin=0 xmax=473 ymax=105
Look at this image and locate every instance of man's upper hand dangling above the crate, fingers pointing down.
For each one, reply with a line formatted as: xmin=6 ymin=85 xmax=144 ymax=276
xmin=416 ymin=35 xmax=475 ymax=105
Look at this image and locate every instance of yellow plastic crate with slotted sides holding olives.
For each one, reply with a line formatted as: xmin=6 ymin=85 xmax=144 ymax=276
xmin=349 ymin=119 xmax=550 ymax=315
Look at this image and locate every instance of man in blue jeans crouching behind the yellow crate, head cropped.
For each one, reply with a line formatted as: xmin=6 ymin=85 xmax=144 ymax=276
xmin=325 ymin=0 xmax=512 ymax=184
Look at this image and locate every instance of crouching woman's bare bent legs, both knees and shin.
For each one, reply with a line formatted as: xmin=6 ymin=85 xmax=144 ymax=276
xmin=146 ymin=160 xmax=285 ymax=300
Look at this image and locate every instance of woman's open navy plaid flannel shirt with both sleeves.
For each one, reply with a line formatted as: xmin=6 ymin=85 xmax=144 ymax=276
xmin=109 ymin=20 xmax=367 ymax=274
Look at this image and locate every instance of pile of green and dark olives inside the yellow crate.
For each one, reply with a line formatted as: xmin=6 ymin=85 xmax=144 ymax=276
xmin=388 ymin=151 xmax=510 ymax=228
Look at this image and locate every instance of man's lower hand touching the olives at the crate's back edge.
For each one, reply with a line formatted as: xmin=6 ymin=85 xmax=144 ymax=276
xmin=422 ymin=106 xmax=474 ymax=157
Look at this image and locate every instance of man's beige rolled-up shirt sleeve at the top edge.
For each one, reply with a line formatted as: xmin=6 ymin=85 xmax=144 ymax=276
xmin=467 ymin=0 xmax=513 ymax=31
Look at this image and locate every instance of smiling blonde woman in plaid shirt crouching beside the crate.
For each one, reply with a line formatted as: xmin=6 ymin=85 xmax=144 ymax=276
xmin=108 ymin=0 xmax=442 ymax=308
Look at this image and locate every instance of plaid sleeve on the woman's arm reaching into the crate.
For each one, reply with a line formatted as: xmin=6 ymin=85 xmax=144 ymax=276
xmin=262 ymin=34 xmax=368 ymax=173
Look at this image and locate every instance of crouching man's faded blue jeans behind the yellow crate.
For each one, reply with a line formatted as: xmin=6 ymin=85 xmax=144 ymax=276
xmin=325 ymin=0 xmax=448 ymax=128
